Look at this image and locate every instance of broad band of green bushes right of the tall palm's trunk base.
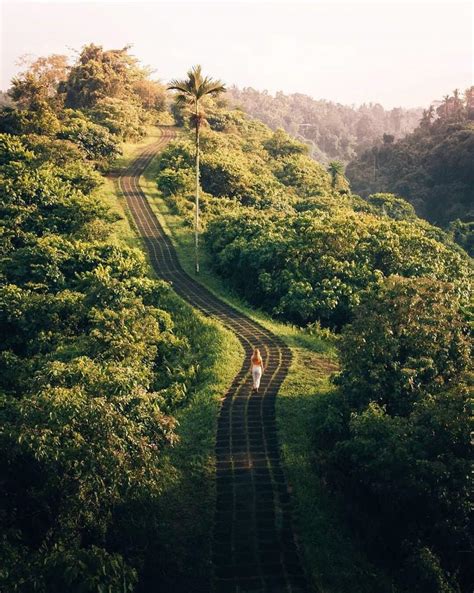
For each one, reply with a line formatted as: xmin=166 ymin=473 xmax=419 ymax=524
xmin=205 ymin=209 xmax=467 ymax=327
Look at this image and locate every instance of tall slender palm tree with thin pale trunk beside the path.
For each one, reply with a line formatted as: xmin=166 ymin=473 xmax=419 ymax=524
xmin=168 ymin=65 xmax=226 ymax=274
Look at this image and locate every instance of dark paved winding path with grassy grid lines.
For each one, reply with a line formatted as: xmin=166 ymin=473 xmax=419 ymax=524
xmin=118 ymin=127 xmax=308 ymax=593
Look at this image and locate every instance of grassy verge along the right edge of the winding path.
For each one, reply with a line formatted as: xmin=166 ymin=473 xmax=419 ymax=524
xmin=141 ymin=127 xmax=390 ymax=593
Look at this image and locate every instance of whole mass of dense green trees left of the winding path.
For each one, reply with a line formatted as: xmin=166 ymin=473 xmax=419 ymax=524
xmin=0 ymin=46 xmax=216 ymax=593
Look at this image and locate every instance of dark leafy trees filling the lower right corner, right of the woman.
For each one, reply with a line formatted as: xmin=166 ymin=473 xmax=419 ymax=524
xmin=314 ymin=276 xmax=474 ymax=593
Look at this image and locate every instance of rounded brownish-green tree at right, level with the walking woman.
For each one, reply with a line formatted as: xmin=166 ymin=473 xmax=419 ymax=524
xmin=339 ymin=277 xmax=470 ymax=415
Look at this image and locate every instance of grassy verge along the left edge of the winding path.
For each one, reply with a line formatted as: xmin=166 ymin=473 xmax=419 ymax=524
xmin=106 ymin=130 xmax=243 ymax=593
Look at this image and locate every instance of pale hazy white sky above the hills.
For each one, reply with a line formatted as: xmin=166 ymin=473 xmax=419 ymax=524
xmin=0 ymin=0 xmax=473 ymax=107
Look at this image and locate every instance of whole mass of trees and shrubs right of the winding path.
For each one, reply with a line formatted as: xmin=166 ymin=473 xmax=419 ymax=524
xmin=162 ymin=95 xmax=473 ymax=593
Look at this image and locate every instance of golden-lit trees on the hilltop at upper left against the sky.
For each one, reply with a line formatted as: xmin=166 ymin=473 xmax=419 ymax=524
xmin=0 ymin=44 xmax=166 ymax=153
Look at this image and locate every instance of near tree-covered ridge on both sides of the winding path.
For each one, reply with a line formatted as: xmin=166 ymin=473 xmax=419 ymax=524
xmin=0 ymin=44 xmax=474 ymax=593
